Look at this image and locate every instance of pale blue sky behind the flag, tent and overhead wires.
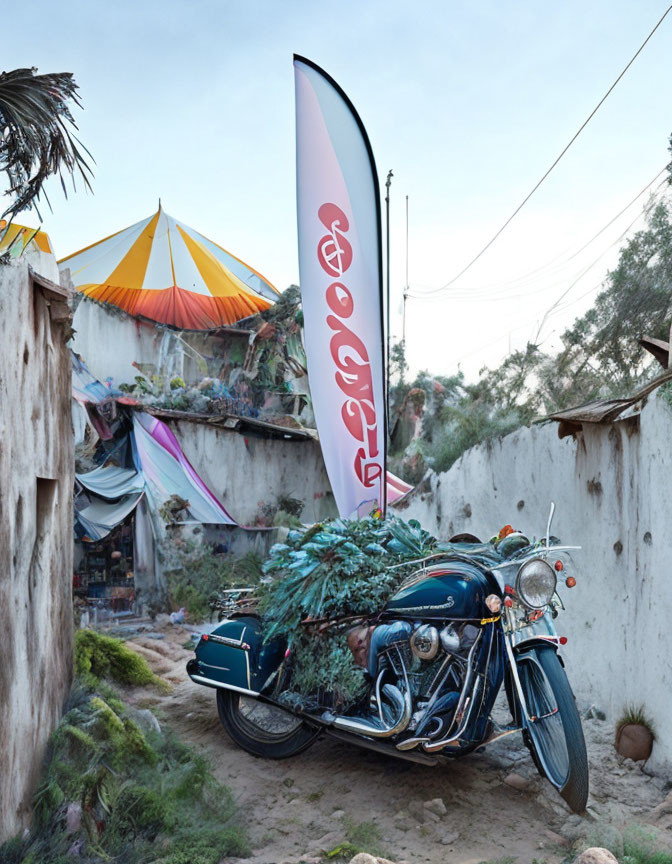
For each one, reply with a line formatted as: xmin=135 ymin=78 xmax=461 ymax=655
xmin=1 ymin=0 xmax=672 ymax=377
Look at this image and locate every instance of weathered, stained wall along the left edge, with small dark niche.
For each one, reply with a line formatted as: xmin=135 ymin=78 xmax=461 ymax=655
xmin=0 ymin=264 xmax=73 ymax=840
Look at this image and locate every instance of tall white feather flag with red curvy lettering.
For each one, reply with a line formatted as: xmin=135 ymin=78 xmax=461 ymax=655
xmin=294 ymin=57 xmax=386 ymax=517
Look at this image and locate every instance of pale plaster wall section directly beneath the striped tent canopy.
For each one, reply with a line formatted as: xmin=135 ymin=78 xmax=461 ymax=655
xmin=71 ymin=297 xmax=165 ymax=386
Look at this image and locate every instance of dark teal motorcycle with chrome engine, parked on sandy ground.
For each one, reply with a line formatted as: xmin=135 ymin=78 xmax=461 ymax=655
xmin=187 ymin=505 xmax=588 ymax=813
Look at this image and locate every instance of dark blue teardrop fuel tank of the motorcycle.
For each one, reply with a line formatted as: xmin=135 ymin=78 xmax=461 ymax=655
xmin=385 ymin=561 xmax=500 ymax=620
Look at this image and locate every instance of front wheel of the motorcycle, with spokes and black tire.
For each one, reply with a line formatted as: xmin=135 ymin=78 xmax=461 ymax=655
xmin=516 ymin=645 xmax=588 ymax=813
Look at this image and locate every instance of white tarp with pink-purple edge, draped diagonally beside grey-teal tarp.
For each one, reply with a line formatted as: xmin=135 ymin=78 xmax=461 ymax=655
xmin=133 ymin=411 xmax=237 ymax=525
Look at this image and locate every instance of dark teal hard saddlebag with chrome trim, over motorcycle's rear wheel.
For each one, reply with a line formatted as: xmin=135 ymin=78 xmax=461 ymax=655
xmin=187 ymin=616 xmax=286 ymax=696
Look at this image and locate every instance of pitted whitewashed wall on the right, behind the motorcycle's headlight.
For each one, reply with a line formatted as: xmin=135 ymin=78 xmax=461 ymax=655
xmin=400 ymin=395 xmax=672 ymax=765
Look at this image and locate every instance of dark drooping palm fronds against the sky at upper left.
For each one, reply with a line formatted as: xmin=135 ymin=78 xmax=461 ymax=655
xmin=0 ymin=68 xmax=93 ymax=222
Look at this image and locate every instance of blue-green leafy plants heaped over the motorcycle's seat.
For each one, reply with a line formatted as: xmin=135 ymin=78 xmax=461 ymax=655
xmin=258 ymin=517 xmax=437 ymax=706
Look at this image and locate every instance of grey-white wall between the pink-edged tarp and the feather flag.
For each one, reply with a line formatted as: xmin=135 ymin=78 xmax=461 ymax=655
xmin=164 ymin=420 xmax=337 ymax=525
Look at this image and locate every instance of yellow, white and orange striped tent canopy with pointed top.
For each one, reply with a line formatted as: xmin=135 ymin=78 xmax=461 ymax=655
xmin=58 ymin=202 xmax=278 ymax=330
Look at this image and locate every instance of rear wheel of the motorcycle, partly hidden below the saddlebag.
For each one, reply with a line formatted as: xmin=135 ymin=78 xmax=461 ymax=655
xmin=217 ymin=689 xmax=320 ymax=759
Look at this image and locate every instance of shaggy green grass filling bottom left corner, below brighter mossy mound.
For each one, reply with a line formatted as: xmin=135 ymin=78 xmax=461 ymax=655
xmin=0 ymin=677 xmax=249 ymax=864
